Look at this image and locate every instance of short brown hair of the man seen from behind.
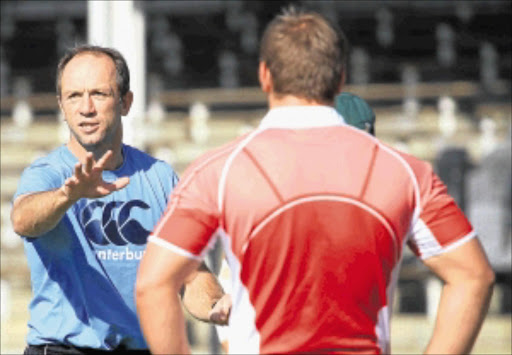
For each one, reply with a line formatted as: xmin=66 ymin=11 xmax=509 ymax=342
xmin=260 ymin=7 xmax=348 ymax=102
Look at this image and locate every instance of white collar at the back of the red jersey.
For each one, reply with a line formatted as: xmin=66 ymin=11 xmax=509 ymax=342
xmin=259 ymin=106 xmax=346 ymax=129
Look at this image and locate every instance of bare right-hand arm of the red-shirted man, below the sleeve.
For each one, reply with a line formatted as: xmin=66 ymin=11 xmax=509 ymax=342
xmin=425 ymin=238 xmax=494 ymax=354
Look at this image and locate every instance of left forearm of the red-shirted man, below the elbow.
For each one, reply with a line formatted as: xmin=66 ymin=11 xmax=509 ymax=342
xmin=137 ymin=284 xmax=190 ymax=354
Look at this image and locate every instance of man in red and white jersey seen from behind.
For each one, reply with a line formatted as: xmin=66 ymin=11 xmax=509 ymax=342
xmin=137 ymin=9 xmax=494 ymax=354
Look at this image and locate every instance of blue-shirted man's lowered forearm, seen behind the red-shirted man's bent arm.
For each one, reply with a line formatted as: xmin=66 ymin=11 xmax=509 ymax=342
xmin=183 ymin=264 xmax=224 ymax=322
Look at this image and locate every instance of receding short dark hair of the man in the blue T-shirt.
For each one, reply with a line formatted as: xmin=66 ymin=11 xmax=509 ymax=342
xmin=55 ymin=44 xmax=130 ymax=98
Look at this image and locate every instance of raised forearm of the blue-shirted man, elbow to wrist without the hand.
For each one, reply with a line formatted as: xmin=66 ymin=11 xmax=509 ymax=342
xmin=11 ymin=188 xmax=75 ymax=237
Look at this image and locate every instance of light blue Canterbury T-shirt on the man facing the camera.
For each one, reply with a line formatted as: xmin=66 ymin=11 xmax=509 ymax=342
xmin=14 ymin=145 xmax=178 ymax=349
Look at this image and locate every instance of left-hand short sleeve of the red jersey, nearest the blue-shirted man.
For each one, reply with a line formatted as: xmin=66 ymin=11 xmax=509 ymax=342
xmin=148 ymin=151 xmax=219 ymax=260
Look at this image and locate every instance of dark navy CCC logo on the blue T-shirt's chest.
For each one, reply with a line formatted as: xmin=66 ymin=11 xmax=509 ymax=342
xmin=80 ymin=200 xmax=149 ymax=245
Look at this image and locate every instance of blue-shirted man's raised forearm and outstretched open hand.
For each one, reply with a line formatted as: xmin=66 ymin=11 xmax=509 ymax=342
xmin=11 ymin=151 xmax=129 ymax=237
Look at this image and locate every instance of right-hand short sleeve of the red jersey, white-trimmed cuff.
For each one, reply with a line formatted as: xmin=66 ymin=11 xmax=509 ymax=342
xmin=408 ymin=163 xmax=476 ymax=259
